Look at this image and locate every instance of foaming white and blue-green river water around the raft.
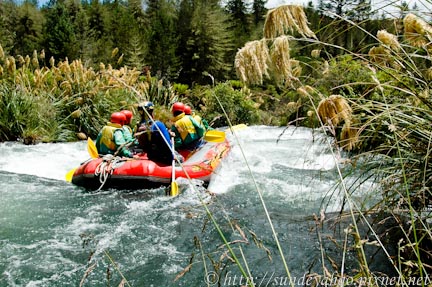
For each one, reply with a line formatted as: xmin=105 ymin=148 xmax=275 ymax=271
xmin=0 ymin=126 xmax=378 ymax=286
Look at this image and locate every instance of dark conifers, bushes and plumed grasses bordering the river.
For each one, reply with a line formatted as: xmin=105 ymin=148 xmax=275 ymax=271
xmin=0 ymin=0 xmax=432 ymax=286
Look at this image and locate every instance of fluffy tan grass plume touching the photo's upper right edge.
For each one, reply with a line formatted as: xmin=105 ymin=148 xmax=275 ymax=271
xmin=403 ymin=13 xmax=432 ymax=47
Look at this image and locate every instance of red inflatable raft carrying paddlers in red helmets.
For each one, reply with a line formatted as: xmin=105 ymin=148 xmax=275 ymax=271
xmin=72 ymin=139 xmax=230 ymax=189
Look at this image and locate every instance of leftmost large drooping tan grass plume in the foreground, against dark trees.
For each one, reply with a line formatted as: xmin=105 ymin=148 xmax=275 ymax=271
xmin=234 ymin=39 xmax=269 ymax=84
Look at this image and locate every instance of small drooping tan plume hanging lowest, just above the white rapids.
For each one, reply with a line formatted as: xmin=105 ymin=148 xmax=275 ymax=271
xmin=317 ymin=95 xmax=352 ymax=126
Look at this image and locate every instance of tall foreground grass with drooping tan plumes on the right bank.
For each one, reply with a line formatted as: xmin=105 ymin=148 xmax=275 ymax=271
xmin=236 ymin=2 xmax=432 ymax=286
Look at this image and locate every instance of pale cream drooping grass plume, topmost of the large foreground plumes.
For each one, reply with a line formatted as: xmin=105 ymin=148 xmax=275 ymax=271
xmin=264 ymin=5 xmax=316 ymax=39
